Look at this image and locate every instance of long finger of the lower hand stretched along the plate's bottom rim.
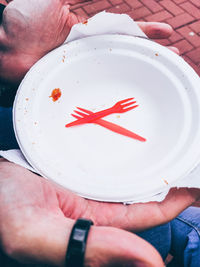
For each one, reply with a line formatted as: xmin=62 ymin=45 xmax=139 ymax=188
xmin=53 ymin=178 xmax=200 ymax=231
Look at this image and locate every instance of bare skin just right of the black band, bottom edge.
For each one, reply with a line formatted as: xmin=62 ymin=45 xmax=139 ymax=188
xmin=85 ymin=226 xmax=164 ymax=267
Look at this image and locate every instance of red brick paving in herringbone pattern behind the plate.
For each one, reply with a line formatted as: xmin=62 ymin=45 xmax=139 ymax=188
xmin=72 ymin=0 xmax=200 ymax=75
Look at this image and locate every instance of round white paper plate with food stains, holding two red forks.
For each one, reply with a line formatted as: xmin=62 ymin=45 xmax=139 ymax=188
xmin=14 ymin=35 xmax=200 ymax=202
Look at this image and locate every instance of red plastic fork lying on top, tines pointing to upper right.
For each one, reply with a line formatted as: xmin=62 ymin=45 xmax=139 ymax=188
xmin=65 ymin=97 xmax=138 ymax=127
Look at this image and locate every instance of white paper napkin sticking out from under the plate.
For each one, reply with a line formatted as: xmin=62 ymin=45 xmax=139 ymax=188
xmin=0 ymin=9 xmax=200 ymax=204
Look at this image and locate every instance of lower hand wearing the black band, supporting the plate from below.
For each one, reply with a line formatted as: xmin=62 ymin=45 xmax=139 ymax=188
xmin=0 ymin=159 xmax=200 ymax=267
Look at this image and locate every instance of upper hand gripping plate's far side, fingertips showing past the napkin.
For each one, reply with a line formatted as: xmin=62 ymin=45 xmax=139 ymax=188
xmin=0 ymin=0 xmax=177 ymax=83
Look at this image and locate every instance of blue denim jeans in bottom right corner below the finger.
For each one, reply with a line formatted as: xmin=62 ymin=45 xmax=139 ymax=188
xmin=139 ymin=207 xmax=200 ymax=267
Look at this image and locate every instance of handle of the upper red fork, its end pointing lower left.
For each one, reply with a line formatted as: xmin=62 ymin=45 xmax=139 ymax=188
xmin=65 ymin=107 xmax=115 ymax=127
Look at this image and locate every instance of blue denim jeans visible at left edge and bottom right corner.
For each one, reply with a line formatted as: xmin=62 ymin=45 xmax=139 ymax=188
xmin=0 ymin=107 xmax=200 ymax=267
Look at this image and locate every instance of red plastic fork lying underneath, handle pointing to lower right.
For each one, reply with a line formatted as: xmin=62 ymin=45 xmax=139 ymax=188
xmin=72 ymin=109 xmax=146 ymax=142
